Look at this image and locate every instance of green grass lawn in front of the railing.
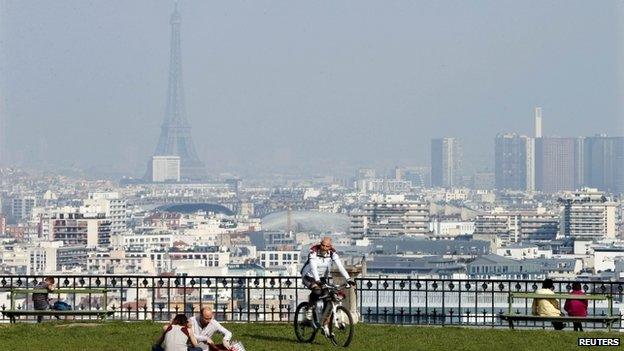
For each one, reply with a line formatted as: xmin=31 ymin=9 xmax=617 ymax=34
xmin=0 ymin=322 xmax=620 ymax=351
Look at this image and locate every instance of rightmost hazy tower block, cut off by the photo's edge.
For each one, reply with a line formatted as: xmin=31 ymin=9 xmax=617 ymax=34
xmin=583 ymin=135 xmax=624 ymax=193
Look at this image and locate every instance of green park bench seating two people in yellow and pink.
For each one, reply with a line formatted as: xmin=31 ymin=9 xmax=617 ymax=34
xmin=499 ymin=292 xmax=620 ymax=331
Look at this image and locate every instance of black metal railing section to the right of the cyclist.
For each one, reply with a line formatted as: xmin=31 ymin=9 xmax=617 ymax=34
xmin=357 ymin=278 xmax=624 ymax=330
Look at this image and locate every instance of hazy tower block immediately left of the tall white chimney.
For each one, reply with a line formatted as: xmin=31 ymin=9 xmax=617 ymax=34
xmin=494 ymin=133 xmax=534 ymax=190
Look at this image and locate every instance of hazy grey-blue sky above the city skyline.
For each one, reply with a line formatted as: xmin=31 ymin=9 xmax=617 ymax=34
xmin=0 ymin=0 xmax=624 ymax=179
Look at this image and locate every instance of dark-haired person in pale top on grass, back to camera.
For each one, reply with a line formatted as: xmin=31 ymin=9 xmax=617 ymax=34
xmin=152 ymin=314 xmax=202 ymax=351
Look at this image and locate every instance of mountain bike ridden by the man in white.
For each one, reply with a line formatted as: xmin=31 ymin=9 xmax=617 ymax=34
xmin=294 ymin=284 xmax=355 ymax=347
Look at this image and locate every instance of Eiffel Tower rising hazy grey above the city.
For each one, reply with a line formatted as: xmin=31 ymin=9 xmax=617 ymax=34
xmin=148 ymin=2 xmax=206 ymax=180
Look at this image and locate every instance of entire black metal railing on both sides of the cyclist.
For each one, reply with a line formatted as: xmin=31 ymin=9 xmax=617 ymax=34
xmin=0 ymin=275 xmax=624 ymax=330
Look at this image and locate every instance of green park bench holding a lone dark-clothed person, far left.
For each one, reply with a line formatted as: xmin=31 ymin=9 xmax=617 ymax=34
xmin=2 ymin=288 xmax=114 ymax=323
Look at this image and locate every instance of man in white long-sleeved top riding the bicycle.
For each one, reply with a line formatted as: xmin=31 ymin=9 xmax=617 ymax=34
xmin=301 ymin=237 xmax=355 ymax=335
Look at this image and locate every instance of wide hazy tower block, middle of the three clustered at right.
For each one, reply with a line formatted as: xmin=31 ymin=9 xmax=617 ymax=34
xmin=535 ymin=138 xmax=579 ymax=193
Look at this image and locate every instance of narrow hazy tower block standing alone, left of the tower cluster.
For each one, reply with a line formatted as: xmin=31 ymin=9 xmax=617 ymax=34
xmin=431 ymin=138 xmax=462 ymax=188
